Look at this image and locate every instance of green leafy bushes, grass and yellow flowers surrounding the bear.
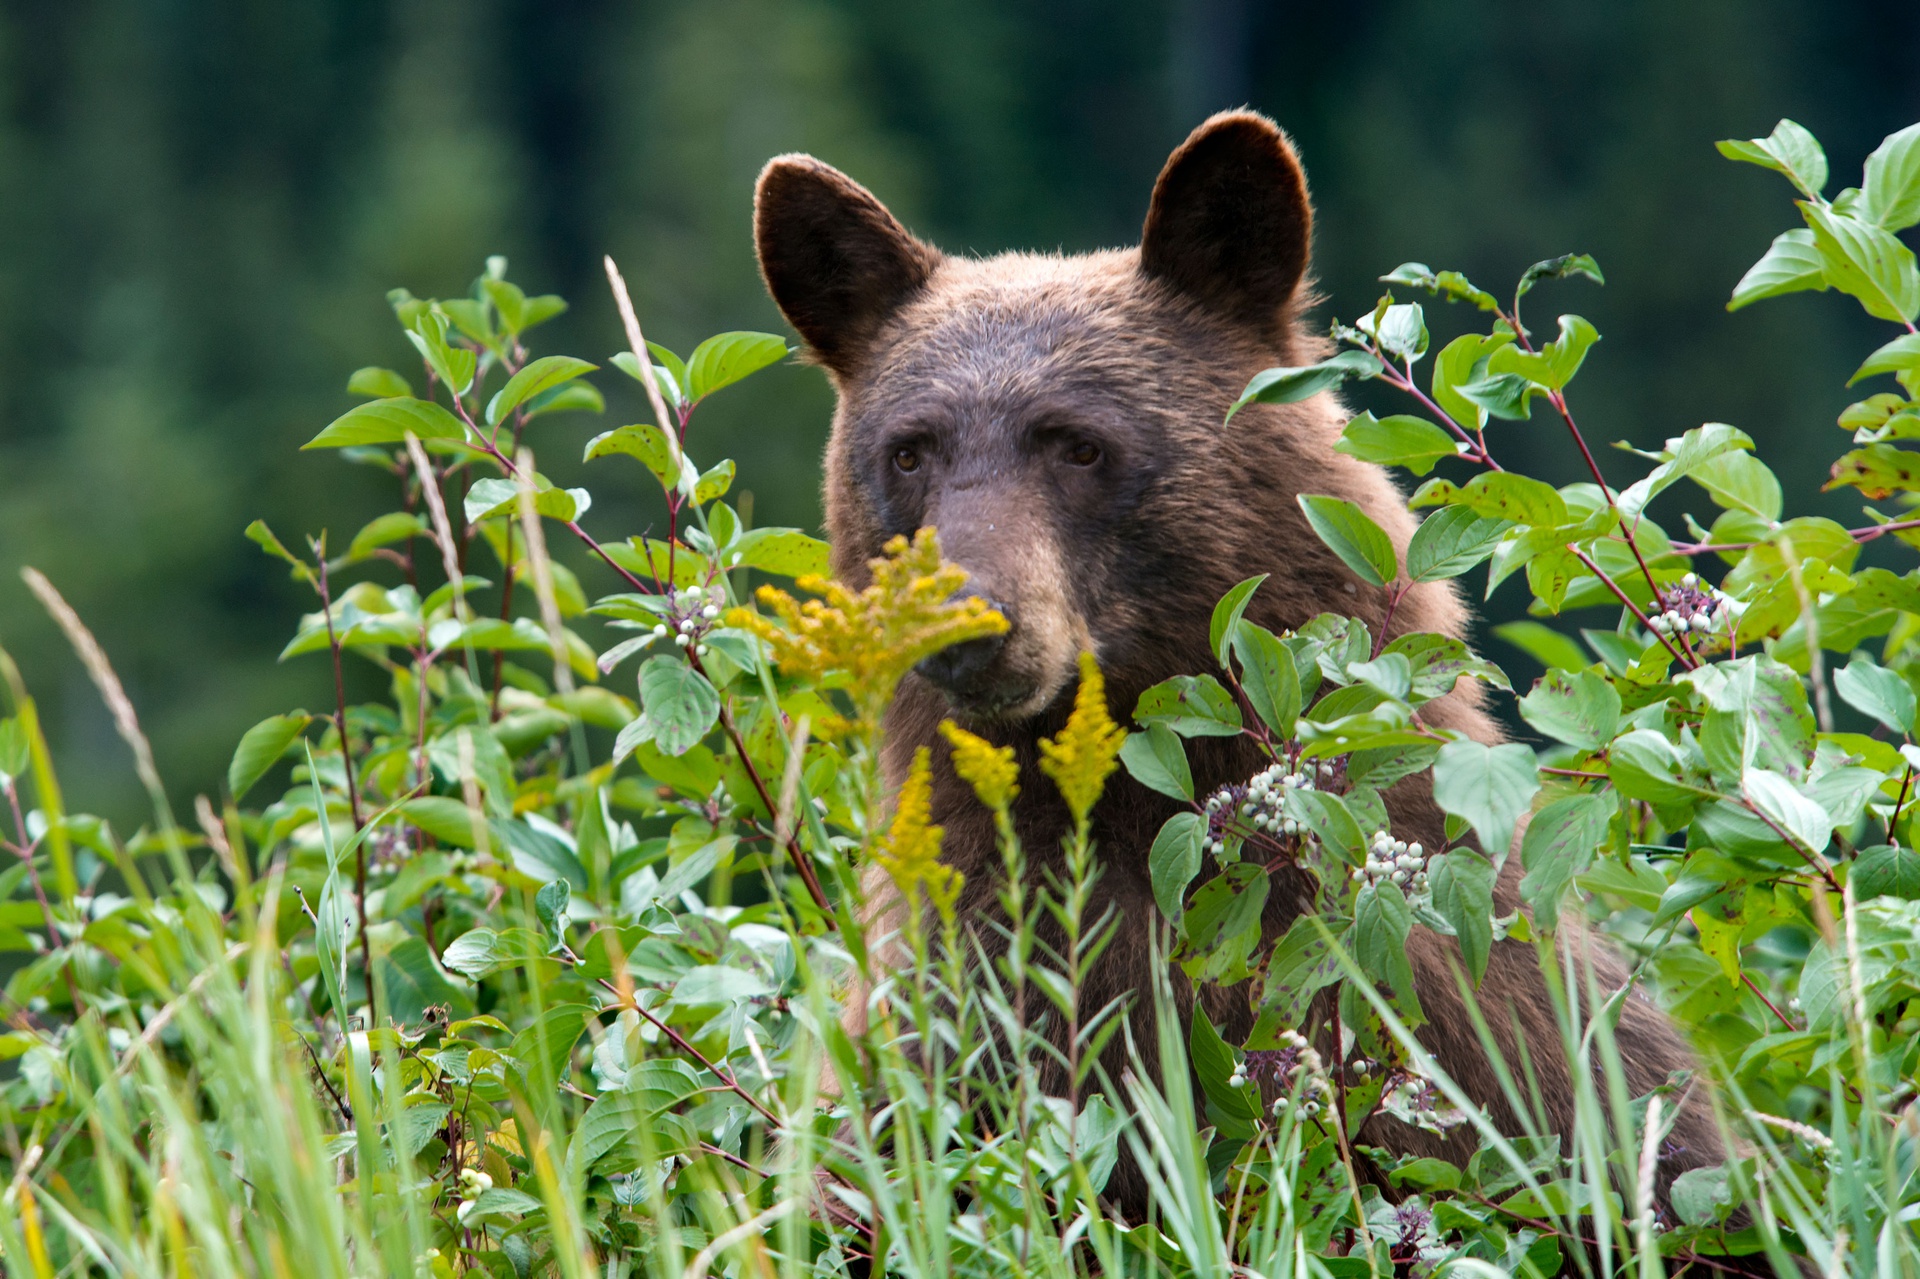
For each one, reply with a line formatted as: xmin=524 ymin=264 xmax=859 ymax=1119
xmin=0 ymin=121 xmax=1920 ymax=1279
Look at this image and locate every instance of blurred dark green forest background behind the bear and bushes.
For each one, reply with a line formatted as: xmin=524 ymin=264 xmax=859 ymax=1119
xmin=0 ymin=0 xmax=1920 ymax=814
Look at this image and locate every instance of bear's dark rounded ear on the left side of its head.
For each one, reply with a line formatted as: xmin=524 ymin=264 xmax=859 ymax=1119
xmin=753 ymin=156 xmax=941 ymax=376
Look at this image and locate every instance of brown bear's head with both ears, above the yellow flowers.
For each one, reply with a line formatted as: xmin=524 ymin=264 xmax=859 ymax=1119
xmin=755 ymin=111 xmax=1443 ymax=722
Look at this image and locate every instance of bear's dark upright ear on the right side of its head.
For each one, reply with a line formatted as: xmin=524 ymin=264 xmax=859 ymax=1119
xmin=1140 ymin=111 xmax=1313 ymax=326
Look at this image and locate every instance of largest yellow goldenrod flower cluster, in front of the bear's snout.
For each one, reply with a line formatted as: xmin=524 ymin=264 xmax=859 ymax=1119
xmin=726 ymin=528 xmax=1006 ymax=728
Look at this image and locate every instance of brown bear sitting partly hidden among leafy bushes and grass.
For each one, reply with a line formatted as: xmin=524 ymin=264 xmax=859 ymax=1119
xmin=755 ymin=111 xmax=1722 ymax=1208
